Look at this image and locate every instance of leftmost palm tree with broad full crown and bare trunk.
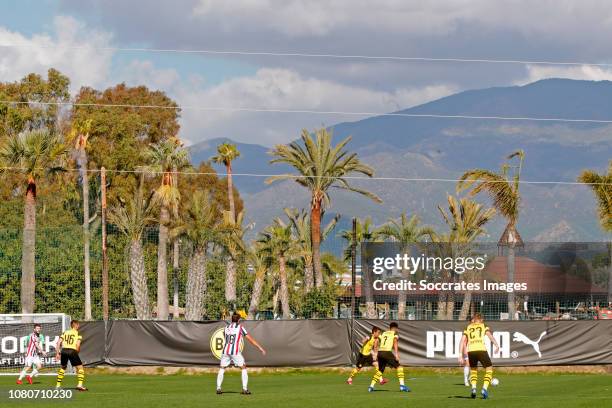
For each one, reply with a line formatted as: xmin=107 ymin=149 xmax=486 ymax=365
xmin=0 ymin=129 xmax=67 ymax=313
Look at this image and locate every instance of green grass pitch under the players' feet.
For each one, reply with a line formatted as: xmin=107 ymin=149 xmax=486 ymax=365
xmin=0 ymin=368 xmax=612 ymax=408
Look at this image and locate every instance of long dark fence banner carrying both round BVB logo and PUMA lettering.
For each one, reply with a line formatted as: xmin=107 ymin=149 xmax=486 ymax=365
xmin=69 ymin=320 xmax=612 ymax=367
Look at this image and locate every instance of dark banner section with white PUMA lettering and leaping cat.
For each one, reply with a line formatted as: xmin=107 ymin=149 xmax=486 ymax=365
xmin=354 ymin=320 xmax=612 ymax=366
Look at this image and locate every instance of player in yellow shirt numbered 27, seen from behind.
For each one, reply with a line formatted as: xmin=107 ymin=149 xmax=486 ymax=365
xmin=459 ymin=313 xmax=499 ymax=399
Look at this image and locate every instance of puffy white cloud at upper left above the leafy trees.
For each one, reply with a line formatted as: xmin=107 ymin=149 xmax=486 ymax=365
xmin=0 ymin=16 xmax=113 ymax=90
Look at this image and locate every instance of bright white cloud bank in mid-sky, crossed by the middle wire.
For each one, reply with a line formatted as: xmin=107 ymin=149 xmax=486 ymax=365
xmin=172 ymin=68 xmax=454 ymax=145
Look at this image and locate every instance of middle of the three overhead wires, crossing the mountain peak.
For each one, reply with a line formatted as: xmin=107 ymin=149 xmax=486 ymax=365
xmin=0 ymin=100 xmax=612 ymax=124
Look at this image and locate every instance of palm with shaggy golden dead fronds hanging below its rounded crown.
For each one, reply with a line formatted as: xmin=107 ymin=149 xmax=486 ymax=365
xmin=145 ymin=138 xmax=189 ymax=320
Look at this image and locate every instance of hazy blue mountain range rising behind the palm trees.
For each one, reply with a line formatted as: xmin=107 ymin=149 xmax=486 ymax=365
xmin=190 ymin=79 xmax=612 ymax=245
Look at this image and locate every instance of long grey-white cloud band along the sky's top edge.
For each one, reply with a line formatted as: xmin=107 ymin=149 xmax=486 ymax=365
xmin=193 ymin=0 xmax=612 ymax=38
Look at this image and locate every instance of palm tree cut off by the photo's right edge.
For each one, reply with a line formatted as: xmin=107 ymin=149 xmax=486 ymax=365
xmin=578 ymin=160 xmax=612 ymax=302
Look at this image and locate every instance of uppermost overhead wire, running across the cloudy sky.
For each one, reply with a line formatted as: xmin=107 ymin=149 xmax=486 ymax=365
xmin=0 ymin=44 xmax=612 ymax=68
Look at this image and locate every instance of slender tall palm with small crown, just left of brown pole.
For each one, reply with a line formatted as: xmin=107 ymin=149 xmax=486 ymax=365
xmin=70 ymin=120 xmax=95 ymax=320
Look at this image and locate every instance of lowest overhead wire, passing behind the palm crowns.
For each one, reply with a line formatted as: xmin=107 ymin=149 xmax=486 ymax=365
xmin=0 ymin=167 xmax=612 ymax=186
